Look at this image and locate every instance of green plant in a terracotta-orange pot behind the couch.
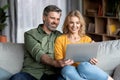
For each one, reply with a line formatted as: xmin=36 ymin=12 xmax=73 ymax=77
xmin=0 ymin=5 xmax=8 ymax=42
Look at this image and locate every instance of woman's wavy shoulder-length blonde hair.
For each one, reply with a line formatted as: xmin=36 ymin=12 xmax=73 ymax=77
xmin=62 ymin=10 xmax=86 ymax=36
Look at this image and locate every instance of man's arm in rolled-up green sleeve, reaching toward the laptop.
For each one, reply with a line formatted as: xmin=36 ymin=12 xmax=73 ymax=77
xmin=24 ymin=33 xmax=63 ymax=67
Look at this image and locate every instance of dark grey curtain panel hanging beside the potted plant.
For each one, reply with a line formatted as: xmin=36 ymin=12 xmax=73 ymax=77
xmin=7 ymin=0 xmax=17 ymax=43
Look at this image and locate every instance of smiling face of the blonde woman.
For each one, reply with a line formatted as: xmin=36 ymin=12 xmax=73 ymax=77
xmin=68 ymin=16 xmax=81 ymax=34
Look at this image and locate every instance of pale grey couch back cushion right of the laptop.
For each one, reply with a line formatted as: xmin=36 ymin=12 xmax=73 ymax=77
xmin=97 ymin=40 xmax=120 ymax=75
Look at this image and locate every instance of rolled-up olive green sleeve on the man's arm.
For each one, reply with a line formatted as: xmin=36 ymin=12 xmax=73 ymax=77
xmin=24 ymin=33 xmax=47 ymax=62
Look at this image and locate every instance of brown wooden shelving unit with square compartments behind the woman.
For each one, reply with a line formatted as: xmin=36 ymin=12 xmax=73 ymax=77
xmin=82 ymin=0 xmax=120 ymax=41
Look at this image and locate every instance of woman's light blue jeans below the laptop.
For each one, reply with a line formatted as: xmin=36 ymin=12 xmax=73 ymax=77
xmin=61 ymin=62 xmax=108 ymax=80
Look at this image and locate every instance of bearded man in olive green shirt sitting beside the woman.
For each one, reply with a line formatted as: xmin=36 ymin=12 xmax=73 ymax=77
xmin=9 ymin=5 xmax=63 ymax=80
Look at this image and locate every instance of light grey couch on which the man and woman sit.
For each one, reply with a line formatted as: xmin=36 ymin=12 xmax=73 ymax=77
xmin=0 ymin=40 xmax=120 ymax=80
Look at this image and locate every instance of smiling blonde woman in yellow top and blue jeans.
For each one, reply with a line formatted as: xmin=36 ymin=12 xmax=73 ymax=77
xmin=55 ymin=10 xmax=113 ymax=80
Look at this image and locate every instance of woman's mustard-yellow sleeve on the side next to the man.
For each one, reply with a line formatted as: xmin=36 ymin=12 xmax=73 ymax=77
xmin=54 ymin=37 xmax=64 ymax=60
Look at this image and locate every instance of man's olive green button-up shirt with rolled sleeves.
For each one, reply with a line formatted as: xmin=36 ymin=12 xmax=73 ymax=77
xmin=22 ymin=25 xmax=61 ymax=80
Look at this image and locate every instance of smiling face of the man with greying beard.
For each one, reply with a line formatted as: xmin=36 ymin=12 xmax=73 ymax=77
xmin=43 ymin=12 xmax=61 ymax=31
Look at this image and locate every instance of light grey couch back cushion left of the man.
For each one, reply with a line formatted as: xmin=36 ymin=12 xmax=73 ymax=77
xmin=0 ymin=43 xmax=24 ymax=74
